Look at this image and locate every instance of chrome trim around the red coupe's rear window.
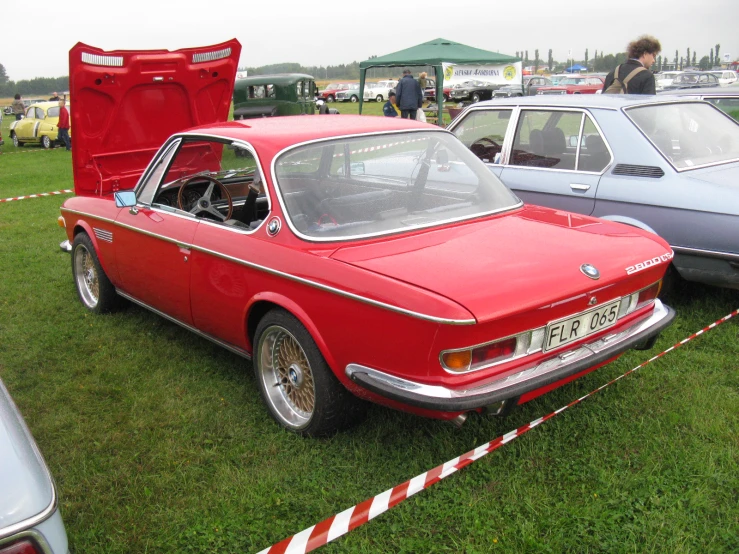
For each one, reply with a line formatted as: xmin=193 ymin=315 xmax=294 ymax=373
xmin=272 ymin=128 xmax=523 ymax=243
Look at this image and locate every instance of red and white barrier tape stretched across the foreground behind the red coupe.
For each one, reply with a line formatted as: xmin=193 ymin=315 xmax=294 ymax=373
xmin=259 ymin=310 xmax=739 ymax=554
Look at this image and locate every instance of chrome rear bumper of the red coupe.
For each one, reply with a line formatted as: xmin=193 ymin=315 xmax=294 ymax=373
xmin=345 ymin=300 xmax=670 ymax=400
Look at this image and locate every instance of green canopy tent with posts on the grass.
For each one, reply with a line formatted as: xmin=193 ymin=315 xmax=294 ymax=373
xmin=359 ymin=38 xmax=521 ymax=125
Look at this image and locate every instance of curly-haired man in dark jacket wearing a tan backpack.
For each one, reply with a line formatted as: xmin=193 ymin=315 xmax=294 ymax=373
xmin=603 ymin=35 xmax=662 ymax=94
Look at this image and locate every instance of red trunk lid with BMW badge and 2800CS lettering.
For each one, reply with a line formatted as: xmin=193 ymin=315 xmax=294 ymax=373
xmin=331 ymin=206 xmax=672 ymax=322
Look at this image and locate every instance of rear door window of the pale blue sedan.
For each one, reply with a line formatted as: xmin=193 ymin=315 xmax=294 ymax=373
xmin=510 ymin=110 xmax=582 ymax=169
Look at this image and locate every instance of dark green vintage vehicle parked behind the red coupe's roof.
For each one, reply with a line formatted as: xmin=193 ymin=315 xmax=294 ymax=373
xmin=233 ymin=73 xmax=318 ymax=119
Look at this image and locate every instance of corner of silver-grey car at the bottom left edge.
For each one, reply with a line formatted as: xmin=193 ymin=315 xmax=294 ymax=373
xmin=0 ymin=381 xmax=68 ymax=554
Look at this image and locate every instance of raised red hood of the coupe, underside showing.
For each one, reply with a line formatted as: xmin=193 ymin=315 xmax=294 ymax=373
xmin=69 ymin=39 xmax=241 ymax=196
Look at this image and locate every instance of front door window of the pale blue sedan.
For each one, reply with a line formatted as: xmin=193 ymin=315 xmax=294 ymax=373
xmin=454 ymin=109 xmax=512 ymax=163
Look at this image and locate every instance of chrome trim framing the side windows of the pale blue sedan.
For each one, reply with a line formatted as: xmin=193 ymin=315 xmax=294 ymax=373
xmin=447 ymin=103 xmax=619 ymax=177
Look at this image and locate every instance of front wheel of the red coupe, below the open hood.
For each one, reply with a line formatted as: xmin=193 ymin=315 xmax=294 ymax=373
xmin=72 ymin=233 xmax=120 ymax=314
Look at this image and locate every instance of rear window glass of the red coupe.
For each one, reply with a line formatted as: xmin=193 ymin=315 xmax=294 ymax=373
xmin=275 ymin=131 xmax=520 ymax=240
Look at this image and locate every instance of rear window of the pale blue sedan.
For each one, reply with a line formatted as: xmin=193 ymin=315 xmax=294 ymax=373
xmin=626 ymin=102 xmax=739 ymax=169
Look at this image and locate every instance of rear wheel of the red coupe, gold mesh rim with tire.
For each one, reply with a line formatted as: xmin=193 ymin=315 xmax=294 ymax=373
xmin=253 ymin=308 xmax=366 ymax=437
